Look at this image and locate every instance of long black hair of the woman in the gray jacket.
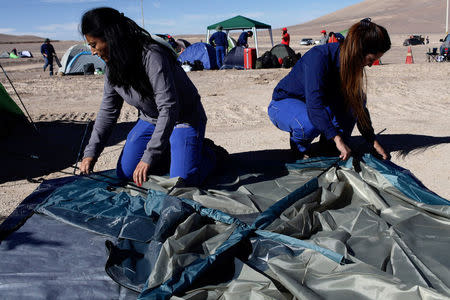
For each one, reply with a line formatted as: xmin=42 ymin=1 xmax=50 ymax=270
xmin=81 ymin=7 xmax=171 ymax=98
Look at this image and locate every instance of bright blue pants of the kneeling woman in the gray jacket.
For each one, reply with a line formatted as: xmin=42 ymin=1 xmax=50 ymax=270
xmin=117 ymin=119 xmax=216 ymax=185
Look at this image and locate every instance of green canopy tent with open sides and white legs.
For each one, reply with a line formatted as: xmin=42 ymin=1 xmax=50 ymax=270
xmin=206 ymin=15 xmax=273 ymax=56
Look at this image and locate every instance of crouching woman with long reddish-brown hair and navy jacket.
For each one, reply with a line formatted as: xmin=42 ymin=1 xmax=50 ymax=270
xmin=268 ymin=18 xmax=391 ymax=160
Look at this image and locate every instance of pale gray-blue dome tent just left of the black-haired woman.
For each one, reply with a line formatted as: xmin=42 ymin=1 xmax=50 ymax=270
xmin=59 ymin=44 xmax=106 ymax=75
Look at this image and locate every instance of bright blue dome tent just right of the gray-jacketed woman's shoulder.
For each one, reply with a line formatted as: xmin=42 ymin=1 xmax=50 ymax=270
xmin=178 ymin=43 xmax=218 ymax=70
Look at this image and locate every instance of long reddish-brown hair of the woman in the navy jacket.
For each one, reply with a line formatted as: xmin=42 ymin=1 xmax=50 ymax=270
xmin=339 ymin=18 xmax=391 ymax=128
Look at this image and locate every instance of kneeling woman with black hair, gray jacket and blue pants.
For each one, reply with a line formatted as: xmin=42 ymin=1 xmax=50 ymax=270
xmin=80 ymin=7 xmax=216 ymax=186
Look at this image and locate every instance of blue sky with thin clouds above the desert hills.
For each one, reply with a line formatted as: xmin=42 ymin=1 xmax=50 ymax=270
xmin=0 ymin=0 xmax=361 ymax=40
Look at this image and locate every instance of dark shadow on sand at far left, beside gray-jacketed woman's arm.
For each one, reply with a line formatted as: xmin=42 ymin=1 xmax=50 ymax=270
xmin=0 ymin=121 xmax=134 ymax=183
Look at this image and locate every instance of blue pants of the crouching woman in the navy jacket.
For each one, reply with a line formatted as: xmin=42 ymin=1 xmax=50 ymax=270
xmin=268 ymin=98 xmax=356 ymax=153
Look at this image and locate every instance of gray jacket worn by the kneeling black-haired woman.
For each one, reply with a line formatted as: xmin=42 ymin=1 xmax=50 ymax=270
xmin=84 ymin=44 xmax=206 ymax=165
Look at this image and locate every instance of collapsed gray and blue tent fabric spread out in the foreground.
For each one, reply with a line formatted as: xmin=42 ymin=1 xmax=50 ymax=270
xmin=0 ymin=155 xmax=450 ymax=300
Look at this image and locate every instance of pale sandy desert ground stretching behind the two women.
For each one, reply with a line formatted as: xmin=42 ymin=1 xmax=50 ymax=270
xmin=0 ymin=35 xmax=450 ymax=221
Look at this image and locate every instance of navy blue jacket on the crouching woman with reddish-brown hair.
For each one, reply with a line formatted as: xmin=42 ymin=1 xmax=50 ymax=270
xmin=272 ymin=43 xmax=374 ymax=141
